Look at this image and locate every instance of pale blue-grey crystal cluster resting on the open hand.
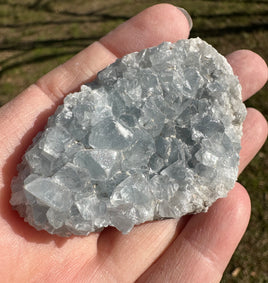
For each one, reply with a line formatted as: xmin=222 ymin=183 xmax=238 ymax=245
xmin=10 ymin=38 xmax=246 ymax=236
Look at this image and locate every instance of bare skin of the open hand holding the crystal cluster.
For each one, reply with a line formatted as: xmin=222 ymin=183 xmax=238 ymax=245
xmin=0 ymin=4 xmax=267 ymax=282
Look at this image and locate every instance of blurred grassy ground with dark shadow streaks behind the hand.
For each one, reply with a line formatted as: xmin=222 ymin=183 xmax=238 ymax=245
xmin=0 ymin=0 xmax=268 ymax=282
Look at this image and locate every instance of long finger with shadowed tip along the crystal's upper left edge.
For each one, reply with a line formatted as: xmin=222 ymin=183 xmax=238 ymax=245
xmin=37 ymin=4 xmax=189 ymax=102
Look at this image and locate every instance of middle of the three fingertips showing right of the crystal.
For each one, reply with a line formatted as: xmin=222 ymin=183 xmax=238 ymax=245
xmin=239 ymin=108 xmax=268 ymax=173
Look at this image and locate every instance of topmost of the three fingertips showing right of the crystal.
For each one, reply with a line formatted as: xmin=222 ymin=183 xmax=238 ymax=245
xmin=227 ymin=50 xmax=268 ymax=100
